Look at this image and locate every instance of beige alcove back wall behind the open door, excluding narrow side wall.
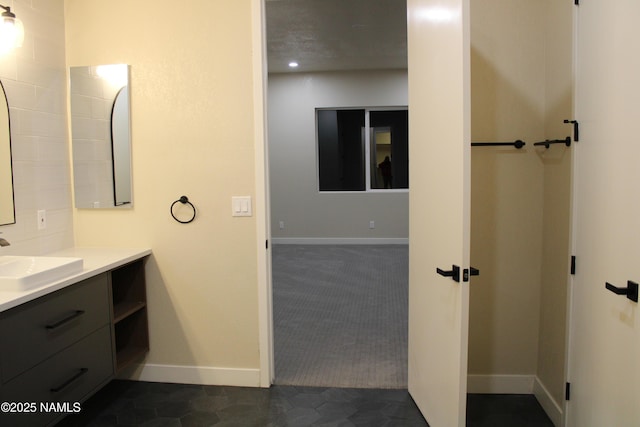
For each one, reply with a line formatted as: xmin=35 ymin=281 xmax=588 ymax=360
xmin=469 ymin=0 xmax=545 ymax=375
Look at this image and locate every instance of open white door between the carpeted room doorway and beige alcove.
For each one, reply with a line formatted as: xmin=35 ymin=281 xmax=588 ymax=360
xmin=407 ymin=0 xmax=470 ymax=427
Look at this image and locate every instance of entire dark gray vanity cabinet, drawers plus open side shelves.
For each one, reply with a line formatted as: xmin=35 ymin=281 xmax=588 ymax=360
xmin=0 ymin=259 xmax=149 ymax=427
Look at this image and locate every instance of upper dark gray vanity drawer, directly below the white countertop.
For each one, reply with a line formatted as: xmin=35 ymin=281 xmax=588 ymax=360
xmin=0 ymin=274 xmax=109 ymax=382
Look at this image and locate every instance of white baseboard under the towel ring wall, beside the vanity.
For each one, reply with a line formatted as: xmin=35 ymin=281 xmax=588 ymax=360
xmin=119 ymin=364 xmax=260 ymax=387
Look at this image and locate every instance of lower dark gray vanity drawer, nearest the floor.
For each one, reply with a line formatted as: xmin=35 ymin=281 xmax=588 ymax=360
xmin=0 ymin=326 xmax=113 ymax=427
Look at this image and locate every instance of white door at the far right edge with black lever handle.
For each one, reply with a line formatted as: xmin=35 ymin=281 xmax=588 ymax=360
xmin=568 ymin=0 xmax=640 ymax=427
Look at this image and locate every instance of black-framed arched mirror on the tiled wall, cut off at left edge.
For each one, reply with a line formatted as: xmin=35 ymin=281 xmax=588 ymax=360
xmin=0 ymin=82 xmax=16 ymax=225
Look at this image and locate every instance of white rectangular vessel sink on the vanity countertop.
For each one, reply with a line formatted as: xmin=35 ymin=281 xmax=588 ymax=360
xmin=0 ymin=255 xmax=83 ymax=291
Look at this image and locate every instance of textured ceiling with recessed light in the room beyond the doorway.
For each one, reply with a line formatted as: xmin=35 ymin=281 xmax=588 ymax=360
xmin=266 ymin=0 xmax=407 ymax=73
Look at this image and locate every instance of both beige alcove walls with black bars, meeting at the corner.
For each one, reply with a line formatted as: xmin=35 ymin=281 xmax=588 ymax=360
xmin=469 ymin=0 xmax=573 ymax=412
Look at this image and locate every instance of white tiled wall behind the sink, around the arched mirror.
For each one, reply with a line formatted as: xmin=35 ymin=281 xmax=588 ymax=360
xmin=0 ymin=0 xmax=73 ymax=255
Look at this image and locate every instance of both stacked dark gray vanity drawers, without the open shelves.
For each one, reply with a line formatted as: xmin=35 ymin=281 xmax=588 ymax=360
xmin=0 ymin=273 xmax=113 ymax=426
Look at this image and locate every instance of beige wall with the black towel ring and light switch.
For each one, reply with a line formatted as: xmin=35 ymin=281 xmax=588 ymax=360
xmin=65 ymin=0 xmax=259 ymax=378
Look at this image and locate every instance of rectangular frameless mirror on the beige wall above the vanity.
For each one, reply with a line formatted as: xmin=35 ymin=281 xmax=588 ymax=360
xmin=69 ymin=64 xmax=133 ymax=209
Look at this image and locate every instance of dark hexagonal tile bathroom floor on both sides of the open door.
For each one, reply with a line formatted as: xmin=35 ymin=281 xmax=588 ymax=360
xmin=58 ymin=381 xmax=553 ymax=427
